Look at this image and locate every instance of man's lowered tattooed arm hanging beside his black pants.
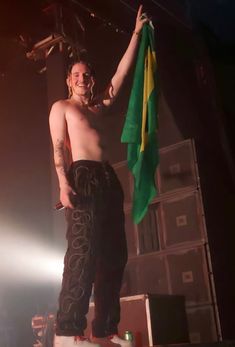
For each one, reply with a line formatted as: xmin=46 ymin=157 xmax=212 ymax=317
xmin=49 ymin=101 xmax=75 ymax=208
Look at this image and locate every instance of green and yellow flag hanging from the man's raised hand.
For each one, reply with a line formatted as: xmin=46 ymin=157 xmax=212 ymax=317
xmin=121 ymin=24 xmax=159 ymax=223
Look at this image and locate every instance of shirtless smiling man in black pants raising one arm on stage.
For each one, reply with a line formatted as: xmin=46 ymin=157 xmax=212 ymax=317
xmin=50 ymin=6 xmax=148 ymax=347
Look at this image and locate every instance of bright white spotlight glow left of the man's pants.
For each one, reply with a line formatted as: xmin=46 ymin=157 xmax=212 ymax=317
xmin=0 ymin=227 xmax=64 ymax=283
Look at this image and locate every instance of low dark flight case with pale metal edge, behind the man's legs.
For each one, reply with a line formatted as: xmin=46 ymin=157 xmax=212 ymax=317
xmin=85 ymin=294 xmax=189 ymax=347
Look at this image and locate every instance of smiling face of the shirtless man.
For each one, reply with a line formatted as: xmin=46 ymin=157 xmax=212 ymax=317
xmin=67 ymin=63 xmax=94 ymax=96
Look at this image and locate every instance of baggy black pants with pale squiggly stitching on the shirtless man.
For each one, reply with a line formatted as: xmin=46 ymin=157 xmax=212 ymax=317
xmin=56 ymin=160 xmax=127 ymax=337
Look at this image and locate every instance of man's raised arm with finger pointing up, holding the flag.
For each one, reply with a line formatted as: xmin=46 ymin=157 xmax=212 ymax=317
xmin=103 ymin=5 xmax=149 ymax=106
